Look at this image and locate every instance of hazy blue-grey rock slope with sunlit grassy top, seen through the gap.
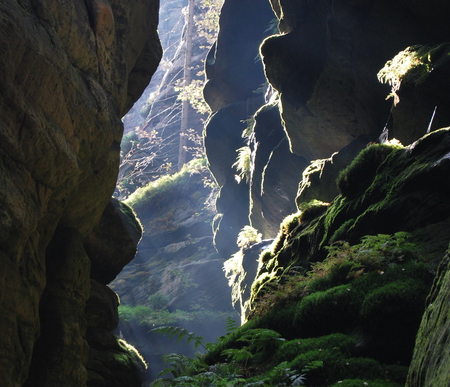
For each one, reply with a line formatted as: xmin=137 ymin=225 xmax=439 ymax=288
xmin=111 ymin=161 xmax=237 ymax=381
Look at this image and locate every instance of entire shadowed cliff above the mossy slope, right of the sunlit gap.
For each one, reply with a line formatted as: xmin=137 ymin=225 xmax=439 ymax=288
xmin=205 ymin=0 xmax=449 ymax=257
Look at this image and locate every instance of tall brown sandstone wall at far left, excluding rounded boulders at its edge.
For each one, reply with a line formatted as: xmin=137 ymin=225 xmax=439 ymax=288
xmin=0 ymin=0 xmax=161 ymax=386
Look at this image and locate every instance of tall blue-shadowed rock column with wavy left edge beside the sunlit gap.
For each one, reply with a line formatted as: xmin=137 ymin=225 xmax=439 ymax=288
xmin=204 ymin=0 xmax=276 ymax=258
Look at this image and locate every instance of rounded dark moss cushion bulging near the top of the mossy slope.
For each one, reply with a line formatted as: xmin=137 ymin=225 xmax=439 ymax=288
xmin=336 ymin=143 xmax=402 ymax=198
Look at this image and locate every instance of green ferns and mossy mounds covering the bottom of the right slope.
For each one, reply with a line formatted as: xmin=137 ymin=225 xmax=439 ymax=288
xmin=146 ymin=233 xmax=431 ymax=387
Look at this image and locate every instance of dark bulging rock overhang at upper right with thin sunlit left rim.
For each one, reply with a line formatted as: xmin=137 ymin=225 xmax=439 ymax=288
xmin=261 ymin=0 xmax=449 ymax=160
